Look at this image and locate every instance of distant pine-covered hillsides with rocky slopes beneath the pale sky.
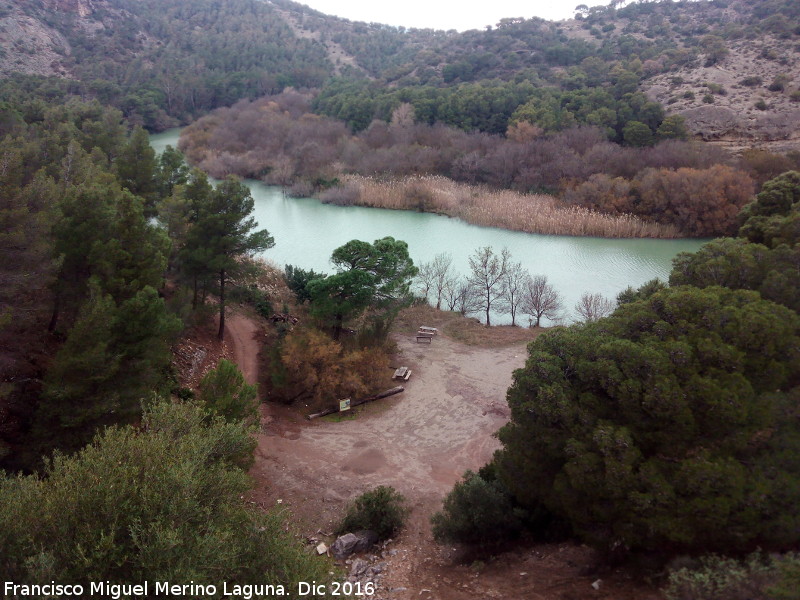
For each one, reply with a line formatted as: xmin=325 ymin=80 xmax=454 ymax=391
xmin=0 ymin=0 xmax=800 ymax=145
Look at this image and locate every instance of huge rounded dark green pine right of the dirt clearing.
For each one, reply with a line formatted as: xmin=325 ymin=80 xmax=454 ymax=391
xmin=495 ymin=286 xmax=800 ymax=553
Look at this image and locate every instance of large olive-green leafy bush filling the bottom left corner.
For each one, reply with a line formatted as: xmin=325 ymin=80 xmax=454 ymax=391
xmin=0 ymin=401 xmax=328 ymax=589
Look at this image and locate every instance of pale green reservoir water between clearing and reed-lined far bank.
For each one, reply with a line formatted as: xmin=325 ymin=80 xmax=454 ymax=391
xmin=150 ymin=129 xmax=705 ymax=324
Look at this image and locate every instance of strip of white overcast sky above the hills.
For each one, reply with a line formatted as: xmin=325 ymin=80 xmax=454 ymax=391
xmin=298 ymin=0 xmax=608 ymax=31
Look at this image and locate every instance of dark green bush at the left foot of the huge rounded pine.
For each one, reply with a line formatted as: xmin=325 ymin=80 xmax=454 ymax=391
xmin=431 ymin=471 xmax=523 ymax=547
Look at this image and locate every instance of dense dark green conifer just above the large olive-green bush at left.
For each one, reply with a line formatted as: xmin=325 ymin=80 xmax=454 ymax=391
xmin=32 ymin=279 xmax=182 ymax=460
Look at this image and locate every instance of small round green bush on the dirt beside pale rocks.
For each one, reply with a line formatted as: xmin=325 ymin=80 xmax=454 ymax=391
xmin=336 ymin=485 xmax=409 ymax=540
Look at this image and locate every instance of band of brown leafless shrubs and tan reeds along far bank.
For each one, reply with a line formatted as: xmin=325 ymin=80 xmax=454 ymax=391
xmin=180 ymin=92 xmax=752 ymax=237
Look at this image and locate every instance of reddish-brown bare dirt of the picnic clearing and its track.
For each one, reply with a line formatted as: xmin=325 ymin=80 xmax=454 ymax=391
xmin=220 ymin=308 xmax=661 ymax=600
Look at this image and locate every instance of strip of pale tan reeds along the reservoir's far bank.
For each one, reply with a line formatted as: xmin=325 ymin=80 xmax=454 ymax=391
xmin=340 ymin=175 xmax=681 ymax=238
